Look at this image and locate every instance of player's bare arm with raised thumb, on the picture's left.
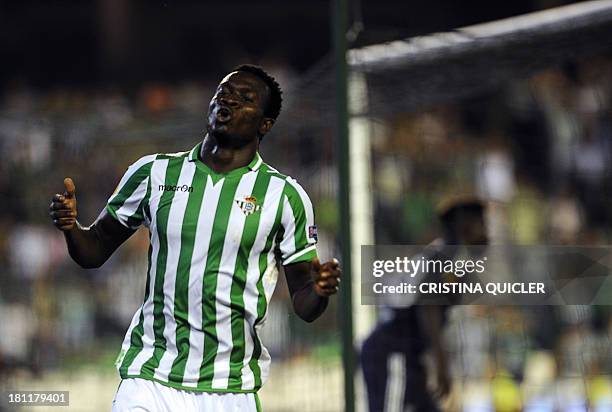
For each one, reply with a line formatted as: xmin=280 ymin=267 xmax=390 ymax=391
xmin=49 ymin=178 xmax=134 ymax=269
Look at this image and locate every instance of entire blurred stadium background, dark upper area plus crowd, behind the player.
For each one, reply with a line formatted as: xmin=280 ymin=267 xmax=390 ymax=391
xmin=0 ymin=0 xmax=612 ymax=412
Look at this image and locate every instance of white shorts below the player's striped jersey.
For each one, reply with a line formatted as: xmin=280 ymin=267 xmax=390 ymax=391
xmin=112 ymin=378 xmax=261 ymax=412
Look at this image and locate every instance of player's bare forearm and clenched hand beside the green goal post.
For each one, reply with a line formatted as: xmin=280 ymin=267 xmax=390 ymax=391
xmin=284 ymin=258 xmax=342 ymax=322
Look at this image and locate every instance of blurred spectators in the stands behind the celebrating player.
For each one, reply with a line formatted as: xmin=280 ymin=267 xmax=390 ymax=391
xmin=0 ymin=50 xmax=612 ymax=411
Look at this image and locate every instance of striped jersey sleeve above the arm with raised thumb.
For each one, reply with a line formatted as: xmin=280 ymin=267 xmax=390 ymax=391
xmin=106 ymin=155 xmax=155 ymax=229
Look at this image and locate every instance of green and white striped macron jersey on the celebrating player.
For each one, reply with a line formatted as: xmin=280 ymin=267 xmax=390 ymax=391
xmin=106 ymin=143 xmax=316 ymax=392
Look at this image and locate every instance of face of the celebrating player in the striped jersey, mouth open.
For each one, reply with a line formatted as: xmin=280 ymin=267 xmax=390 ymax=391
xmin=208 ymin=72 xmax=270 ymax=144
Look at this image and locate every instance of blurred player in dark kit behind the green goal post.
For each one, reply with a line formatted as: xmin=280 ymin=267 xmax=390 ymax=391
xmin=361 ymin=197 xmax=488 ymax=412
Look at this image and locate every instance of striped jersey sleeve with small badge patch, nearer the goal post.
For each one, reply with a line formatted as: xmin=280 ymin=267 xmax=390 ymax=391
xmin=280 ymin=178 xmax=317 ymax=265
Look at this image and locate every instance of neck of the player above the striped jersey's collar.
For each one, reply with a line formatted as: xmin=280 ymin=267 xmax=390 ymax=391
xmin=199 ymin=134 xmax=259 ymax=173
